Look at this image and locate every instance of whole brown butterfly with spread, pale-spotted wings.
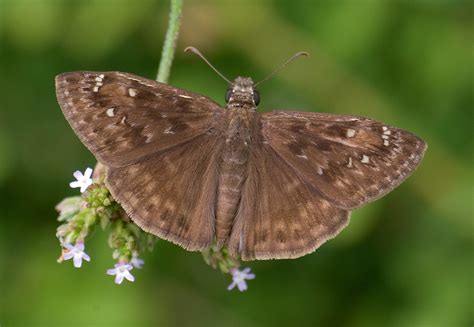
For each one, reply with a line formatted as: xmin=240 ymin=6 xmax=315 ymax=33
xmin=56 ymin=48 xmax=427 ymax=260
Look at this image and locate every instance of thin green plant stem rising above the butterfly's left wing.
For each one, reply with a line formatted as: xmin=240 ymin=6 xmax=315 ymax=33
xmin=156 ymin=0 xmax=183 ymax=83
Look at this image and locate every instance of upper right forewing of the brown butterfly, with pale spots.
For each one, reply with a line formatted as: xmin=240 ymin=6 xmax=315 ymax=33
xmin=261 ymin=111 xmax=426 ymax=210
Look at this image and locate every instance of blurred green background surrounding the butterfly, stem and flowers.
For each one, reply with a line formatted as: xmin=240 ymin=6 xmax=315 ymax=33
xmin=0 ymin=0 xmax=474 ymax=327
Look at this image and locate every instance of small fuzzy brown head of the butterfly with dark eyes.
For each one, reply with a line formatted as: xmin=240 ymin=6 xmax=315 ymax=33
xmin=225 ymin=76 xmax=260 ymax=107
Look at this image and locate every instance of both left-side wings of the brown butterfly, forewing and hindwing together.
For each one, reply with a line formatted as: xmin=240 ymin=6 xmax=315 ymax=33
xmin=56 ymin=72 xmax=224 ymax=250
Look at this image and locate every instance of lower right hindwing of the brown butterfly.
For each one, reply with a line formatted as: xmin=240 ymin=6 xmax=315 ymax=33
xmin=228 ymin=131 xmax=350 ymax=260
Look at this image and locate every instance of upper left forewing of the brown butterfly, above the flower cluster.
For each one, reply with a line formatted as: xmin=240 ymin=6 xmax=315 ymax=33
xmin=56 ymin=72 xmax=223 ymax=167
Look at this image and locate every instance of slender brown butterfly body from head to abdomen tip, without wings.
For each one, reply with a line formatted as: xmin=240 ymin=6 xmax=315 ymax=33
xmin=216 ymin=77 xmax=257 ymax=245
